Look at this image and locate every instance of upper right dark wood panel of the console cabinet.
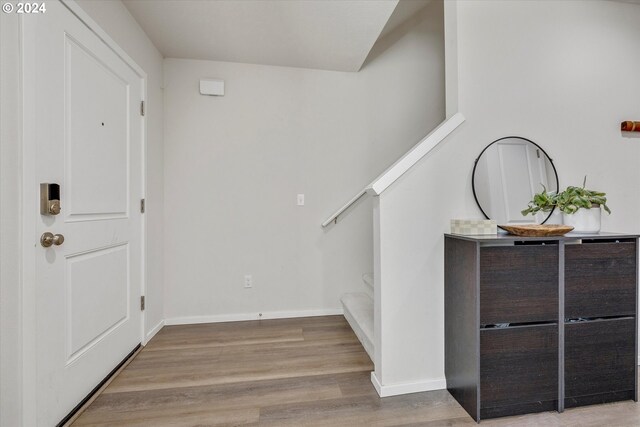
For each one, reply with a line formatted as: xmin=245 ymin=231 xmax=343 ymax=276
xmin=565 ymin=242 xmax=636 ymax=318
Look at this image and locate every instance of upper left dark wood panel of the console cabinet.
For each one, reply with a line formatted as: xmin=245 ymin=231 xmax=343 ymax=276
xmin=480 ymin=245 xmax=558 ymax=325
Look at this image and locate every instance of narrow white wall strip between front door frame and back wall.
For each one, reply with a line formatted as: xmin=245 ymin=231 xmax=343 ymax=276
xmin=78 ymin=0 xmax=164 ymax=342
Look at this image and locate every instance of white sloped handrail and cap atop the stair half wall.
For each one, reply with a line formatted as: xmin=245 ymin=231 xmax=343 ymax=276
xmin=322 ymin=113 xmax=465 ymax=228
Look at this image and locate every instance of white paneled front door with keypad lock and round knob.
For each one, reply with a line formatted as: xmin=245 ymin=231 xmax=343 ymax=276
xmin=23 ymin=1 xmax=144 ymax=425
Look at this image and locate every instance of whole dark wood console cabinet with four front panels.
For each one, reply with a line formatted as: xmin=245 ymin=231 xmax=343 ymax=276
xmin=445 ymin=233 xmax=638 ymax=421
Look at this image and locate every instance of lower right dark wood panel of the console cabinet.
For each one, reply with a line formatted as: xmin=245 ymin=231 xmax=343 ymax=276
xmin=565 ymin=318 xmax=636 ymax=407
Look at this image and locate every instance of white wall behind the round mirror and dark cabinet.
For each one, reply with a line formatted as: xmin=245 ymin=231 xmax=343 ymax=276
xmin=379 ymin=1 xmax=640 ymax=390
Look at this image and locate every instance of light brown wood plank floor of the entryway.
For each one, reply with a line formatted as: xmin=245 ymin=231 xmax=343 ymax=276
xmin=73 ymin=316 xmax=640 ymax=427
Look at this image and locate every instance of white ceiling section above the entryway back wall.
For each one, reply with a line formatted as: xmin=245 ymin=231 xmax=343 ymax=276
xmin=123 ymin=0 xmax=402 ymax=71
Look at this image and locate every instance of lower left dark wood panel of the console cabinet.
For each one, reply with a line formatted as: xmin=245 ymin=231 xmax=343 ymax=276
xmin=480 ymin=324 xmax=558 ymax=417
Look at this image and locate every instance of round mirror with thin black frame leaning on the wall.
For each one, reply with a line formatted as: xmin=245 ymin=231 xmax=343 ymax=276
xmin=471 ymin=136 xmax=558 ymax=225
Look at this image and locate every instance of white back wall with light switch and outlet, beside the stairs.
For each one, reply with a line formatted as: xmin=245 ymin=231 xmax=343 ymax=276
xmin=164 ymin=2 xmax=444 ymax=322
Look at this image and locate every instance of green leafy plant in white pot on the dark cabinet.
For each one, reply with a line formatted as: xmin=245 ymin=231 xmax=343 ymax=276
xmin=522 ymin=176 xmax=611 ymax=233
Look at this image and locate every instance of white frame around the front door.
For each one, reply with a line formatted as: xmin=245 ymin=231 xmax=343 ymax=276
xmin=20 ymin=0 xmax=147 ymax=425
